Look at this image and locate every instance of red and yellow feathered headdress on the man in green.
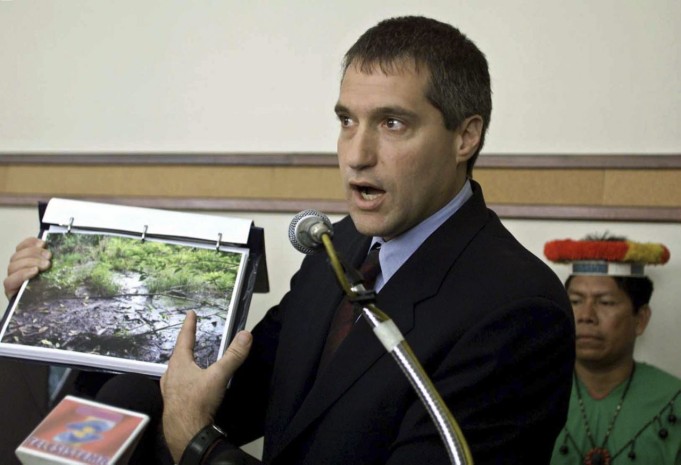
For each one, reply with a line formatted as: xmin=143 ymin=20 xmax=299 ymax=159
xmin=544 ymin=239 xmax=669 ymax=277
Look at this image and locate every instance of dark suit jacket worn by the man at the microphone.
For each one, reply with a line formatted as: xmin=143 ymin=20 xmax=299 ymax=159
xmin=218 ymin=183 xmax=574 ymax=465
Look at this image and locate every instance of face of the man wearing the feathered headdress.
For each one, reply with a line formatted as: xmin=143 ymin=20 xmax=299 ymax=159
xmin=567 ymin=276 xmax=650 ymax=367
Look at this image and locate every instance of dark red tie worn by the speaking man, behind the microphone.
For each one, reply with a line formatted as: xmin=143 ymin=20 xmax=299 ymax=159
xmin=319 ymin=243 xmax=381 ymax=369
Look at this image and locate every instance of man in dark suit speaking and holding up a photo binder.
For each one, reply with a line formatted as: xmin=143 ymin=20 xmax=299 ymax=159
xmin=5 ymin=17 xmax=574 ymax=465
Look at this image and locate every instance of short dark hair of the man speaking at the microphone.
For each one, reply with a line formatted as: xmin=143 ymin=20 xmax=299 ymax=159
xmin=342 ymin=16 xmax=492 ymax=176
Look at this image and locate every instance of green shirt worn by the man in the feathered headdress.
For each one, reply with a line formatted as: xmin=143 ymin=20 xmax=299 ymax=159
xmin=551 ymin=362 xmax=681 ymax=465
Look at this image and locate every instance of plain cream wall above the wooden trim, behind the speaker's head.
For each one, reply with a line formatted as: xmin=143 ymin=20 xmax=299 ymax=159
xmin=0 ymin=0 xmax=681 ymax=154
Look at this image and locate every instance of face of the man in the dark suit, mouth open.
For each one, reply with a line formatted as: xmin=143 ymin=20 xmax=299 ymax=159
xmin=336 ymin=65 xmax=466 ymax=240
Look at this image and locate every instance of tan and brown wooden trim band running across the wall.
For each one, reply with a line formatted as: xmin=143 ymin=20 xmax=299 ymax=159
xmin=0 ymin=153 xmax=681 ymax=222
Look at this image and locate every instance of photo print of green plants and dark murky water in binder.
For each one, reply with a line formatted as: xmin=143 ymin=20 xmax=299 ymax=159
xmin=0 ymin=232 xmax=246 ymax=371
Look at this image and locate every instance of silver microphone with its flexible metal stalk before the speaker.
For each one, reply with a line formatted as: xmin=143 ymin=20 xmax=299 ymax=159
xmin=289 ymin=210 xmax=473 ymax=465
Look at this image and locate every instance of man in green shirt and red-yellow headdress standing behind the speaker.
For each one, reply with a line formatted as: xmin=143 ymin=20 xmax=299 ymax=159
xmin=544 ymin=236 xmax=681 ymax=465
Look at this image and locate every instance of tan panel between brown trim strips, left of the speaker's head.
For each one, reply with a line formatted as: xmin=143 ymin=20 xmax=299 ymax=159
xmin=0 ymin=165 xmax=342 ymax=199
